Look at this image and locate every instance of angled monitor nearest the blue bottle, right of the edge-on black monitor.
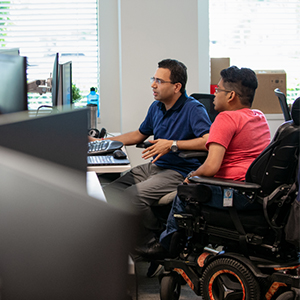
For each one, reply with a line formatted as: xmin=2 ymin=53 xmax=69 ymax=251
xmin=58 ymin=61 xmax=72 ymax=108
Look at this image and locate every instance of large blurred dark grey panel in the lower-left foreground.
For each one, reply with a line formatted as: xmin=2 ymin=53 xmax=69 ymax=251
xmin=0 ymin=144 xmax=136 ymax=300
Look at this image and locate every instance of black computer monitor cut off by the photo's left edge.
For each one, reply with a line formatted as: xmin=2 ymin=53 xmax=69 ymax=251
xmin=0 ymin=54 xmax=27 ymax=114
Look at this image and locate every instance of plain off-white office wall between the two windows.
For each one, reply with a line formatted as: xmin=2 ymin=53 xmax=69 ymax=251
xmin=99 ymin=0 xmax=209 ymax=165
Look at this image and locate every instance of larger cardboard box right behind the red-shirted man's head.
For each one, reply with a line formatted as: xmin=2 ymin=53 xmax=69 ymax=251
xmin=252 ymin=70 xmax=286 ymax=114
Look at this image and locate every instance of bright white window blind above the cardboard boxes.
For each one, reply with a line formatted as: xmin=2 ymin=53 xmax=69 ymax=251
xmin=209 ymin=0 xmax=300 ymax=103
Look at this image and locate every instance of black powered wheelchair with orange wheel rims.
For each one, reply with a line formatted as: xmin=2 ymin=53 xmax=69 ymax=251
xmin=159 ymin=98 xmax=300 ymax=300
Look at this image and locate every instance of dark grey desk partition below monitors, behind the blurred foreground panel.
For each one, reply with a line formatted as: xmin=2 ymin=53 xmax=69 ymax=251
xmin=0 ymin=109 xmax=88 ymax=177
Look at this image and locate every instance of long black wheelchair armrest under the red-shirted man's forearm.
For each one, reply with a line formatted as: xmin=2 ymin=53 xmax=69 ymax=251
xmin=189 ymin=176 xmax=261 ymax=191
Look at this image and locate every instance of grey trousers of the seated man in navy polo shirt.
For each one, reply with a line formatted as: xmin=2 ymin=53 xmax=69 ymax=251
xmin=103 ymin=163 xmax=184 ymax=243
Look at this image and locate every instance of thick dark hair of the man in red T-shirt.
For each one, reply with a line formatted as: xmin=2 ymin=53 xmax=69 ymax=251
xmin=220 ymin=66 xmax=258 ymax=107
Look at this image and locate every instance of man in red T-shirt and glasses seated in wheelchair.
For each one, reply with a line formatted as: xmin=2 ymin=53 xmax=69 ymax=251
xmin=137 ymin=66 xmax=270 ymax=259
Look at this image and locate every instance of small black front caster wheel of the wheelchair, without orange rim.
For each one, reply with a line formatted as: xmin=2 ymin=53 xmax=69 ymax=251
xmin=160 ymin=272 xmax=181 ymax=300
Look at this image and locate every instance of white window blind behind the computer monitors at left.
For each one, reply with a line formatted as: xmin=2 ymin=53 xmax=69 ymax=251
xmin=0 ymin=0 xmax=99 ymax=107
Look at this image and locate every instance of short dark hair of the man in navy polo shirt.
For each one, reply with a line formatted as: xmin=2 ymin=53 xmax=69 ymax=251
xmin=158 ymin=59 xmax=187 ymax=94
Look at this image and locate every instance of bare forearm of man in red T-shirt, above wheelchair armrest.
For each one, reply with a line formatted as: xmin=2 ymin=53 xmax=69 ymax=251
xmin=185 ymin=143 xmax=226 ymax=182
